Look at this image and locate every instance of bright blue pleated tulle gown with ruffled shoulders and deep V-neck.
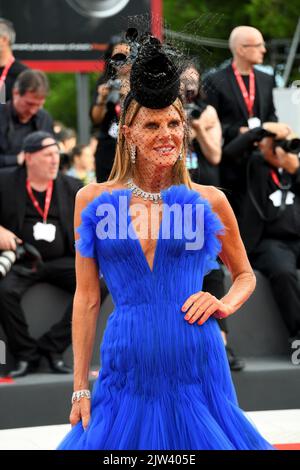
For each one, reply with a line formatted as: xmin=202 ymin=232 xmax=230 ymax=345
xmin=59 ymin=184 xmax=272 ymax=450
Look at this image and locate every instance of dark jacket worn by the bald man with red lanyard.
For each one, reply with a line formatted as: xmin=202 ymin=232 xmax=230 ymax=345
xmin=203 ymin=64 xmax=277 ymax=144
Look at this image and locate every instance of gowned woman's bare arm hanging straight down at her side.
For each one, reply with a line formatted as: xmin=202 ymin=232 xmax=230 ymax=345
xmin=70 ymin=186 xmax=101 ymax=427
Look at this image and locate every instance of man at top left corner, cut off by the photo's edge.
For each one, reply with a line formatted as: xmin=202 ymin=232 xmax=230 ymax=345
xmin=0 ymin=18 xmax=27 ymax=103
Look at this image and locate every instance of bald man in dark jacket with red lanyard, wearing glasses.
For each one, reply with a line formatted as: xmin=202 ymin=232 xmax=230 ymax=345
xmin=205 ymin=26 xmax=277 ymax=144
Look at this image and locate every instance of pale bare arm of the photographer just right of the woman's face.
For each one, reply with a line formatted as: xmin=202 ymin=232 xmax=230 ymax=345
xmin=192 ymin=106 xmax=222 ymax=165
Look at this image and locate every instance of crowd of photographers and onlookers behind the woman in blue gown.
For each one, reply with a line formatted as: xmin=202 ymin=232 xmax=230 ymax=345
xmin=0 ymin=15 xmax=300 ymax=378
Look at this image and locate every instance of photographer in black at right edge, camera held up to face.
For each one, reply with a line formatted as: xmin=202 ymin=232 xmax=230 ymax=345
xmin=233 ymin=127 xmax=300 ymax=341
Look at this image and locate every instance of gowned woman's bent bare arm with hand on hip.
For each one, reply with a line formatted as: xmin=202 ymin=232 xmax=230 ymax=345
xmin=182 ymin=184 xmax=256 ymax=325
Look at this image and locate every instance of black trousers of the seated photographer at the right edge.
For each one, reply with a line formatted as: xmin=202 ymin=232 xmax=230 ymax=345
xmin=249 ymin=239 xmax=300 ymax=337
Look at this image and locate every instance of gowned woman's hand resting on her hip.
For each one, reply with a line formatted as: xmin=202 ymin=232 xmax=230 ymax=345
xmin=181 ymin=291 xmax=234 ymax=325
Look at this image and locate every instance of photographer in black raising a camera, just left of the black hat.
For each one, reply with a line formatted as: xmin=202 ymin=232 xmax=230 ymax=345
xmin=91 ymin=41 xmax=130 ymax=183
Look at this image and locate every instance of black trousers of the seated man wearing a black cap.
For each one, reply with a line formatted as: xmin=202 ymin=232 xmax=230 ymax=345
xmin=0 ymin=257 xmax=107 ymax=361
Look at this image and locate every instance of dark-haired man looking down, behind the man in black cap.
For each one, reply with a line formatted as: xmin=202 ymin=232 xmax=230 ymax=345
xmin=0 ymin=69 xmax=53 ymax=171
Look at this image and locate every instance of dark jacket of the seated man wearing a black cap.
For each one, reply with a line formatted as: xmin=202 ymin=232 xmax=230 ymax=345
xmin=0 ymin=166 xmax=82 ymax=255
